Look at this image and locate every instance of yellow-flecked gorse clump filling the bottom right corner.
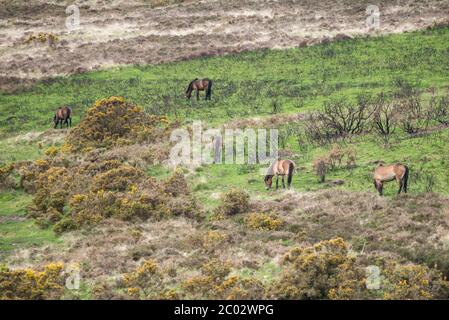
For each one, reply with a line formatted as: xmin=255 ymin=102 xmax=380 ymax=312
xmin=272 ymin=238 xmax=449 ymax=299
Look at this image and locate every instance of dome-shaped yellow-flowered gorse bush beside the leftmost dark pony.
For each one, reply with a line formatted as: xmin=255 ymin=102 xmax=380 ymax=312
xmin=64 ymin=97 xmax=169 ymax=152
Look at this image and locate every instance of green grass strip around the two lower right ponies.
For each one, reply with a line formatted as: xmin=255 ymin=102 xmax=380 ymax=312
xmin=191 ymin=129 xmax=449 ymax=208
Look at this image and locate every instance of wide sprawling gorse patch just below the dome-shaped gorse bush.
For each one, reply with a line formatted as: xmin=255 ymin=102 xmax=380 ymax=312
xmin=23 ymin=158 xmax=199 ymax=232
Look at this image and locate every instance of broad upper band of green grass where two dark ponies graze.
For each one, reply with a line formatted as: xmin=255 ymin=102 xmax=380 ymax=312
xmin=0 ymin=28 xmax=449 ymax=135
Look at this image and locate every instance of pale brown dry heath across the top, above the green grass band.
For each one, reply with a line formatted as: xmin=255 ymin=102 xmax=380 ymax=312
xmin=0 ymin=0 xmax=449 ymax=90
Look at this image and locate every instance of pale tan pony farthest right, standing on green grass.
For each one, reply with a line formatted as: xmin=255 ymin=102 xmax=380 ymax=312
xmin=373 ymin=163 xmax=409 ymax=195
